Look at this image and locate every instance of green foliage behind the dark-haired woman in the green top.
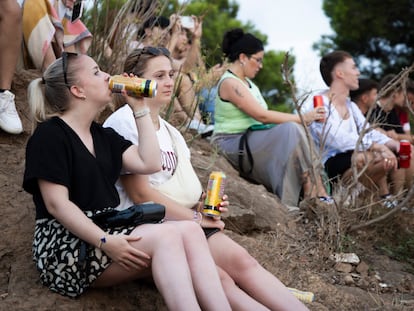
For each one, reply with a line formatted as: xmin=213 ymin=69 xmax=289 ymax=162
xmin=83 ymin=0 xmax=295 ymax=111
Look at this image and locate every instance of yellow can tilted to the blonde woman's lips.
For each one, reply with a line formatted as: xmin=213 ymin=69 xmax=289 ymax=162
xmin=109 ymin=75 xmax=157 ymax=97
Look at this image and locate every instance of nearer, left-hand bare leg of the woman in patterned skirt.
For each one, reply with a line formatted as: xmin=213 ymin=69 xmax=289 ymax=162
xmin=94 ymin=224 xmax=204 ymax=311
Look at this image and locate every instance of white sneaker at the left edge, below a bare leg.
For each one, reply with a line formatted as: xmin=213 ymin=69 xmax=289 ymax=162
xmin=0 ymin=91 xmax=23 ymax=134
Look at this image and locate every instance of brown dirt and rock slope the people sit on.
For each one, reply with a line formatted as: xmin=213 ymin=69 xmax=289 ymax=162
xmin=0 ymin=71 xmax=414 ymax=310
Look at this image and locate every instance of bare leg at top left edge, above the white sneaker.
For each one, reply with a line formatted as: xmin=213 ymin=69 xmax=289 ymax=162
xmin=0 ymin=0 xmax=22 ymax=90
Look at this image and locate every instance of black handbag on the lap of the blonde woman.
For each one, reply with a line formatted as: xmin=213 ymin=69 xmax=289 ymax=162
xmin=91 ymin=202 xmax=165 ymax=229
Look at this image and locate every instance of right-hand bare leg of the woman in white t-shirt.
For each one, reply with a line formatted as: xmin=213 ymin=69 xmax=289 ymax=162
xmin=208 ymin=232 xmax=308 ymax=311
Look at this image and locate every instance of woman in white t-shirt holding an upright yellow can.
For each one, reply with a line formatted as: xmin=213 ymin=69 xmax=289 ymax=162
xmin=104 ymin=47 xmax=307 ymax=310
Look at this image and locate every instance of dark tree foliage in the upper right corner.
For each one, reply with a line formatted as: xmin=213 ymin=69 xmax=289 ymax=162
xmin=314 ymin=0 xmax=414 ymax=80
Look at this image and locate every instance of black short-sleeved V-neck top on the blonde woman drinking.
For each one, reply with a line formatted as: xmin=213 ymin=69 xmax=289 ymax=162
xmin=23 ymin=117 xmax=132 ymax=219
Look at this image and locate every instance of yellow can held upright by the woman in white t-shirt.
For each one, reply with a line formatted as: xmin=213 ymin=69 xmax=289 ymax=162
xmin=203 ymin=171 xmax=226 ymax=216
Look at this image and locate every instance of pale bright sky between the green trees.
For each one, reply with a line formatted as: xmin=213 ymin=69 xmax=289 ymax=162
xmin=236 ymin=0 xmax=333 ymax=93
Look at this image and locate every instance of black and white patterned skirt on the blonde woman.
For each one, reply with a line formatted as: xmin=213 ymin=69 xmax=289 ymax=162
xmin=33 ymin=219 xmax=135 ymax=297
